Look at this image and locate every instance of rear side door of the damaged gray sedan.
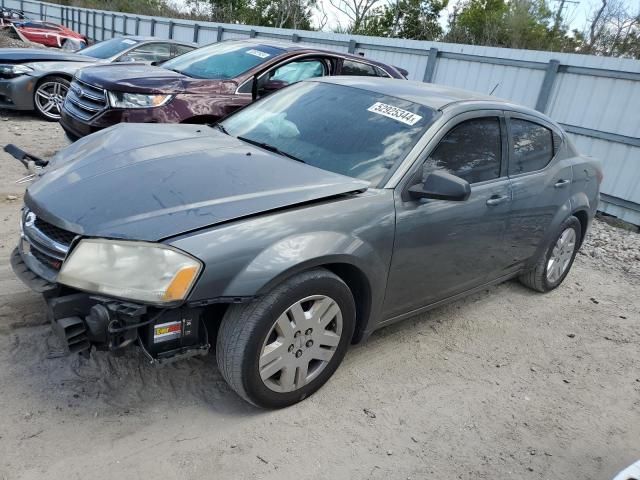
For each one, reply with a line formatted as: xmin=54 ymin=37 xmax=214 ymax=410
xmin=506 ymin=112 xmax=573 ymax=264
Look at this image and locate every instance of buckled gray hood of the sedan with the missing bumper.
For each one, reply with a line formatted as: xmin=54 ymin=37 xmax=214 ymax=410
xmin=25 ymin=124 xmax=368 ymax=241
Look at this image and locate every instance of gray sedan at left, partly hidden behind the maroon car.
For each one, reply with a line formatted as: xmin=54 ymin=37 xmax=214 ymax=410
xmin=0 ymin=36 xmax=197 ymax=121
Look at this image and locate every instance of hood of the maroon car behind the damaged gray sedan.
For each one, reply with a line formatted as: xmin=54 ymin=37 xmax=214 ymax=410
xmin=76 ymin=63 xmax=188 ymax=93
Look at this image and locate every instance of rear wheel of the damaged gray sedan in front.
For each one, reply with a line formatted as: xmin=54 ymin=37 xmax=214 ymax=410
xmin=520 ymin=216 xmax=582 ymax=292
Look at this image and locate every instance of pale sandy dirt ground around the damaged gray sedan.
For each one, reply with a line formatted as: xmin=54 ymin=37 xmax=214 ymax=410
xmin=0 ymin=112 xmax=640 ymax=480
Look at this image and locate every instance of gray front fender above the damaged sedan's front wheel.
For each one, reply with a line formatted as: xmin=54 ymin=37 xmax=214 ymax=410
xmin=169 ymin=189 xmax=395 ymax=318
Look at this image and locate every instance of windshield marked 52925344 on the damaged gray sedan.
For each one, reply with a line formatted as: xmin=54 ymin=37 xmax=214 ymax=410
xmin=221 ymin=82 xmax=438 ymax=186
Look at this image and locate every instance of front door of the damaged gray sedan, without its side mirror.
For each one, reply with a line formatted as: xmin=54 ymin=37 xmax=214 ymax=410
xmin=384 ymin=111 xmax=511 ymax=318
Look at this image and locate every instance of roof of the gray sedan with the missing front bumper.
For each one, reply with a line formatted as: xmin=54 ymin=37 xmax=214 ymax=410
xmin=310 ymin=76 xmax=512 ymax=110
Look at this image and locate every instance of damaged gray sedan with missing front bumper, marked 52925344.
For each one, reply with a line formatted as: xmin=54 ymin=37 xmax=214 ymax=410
xmin=12 ymin=77 xmax=602 ymax=407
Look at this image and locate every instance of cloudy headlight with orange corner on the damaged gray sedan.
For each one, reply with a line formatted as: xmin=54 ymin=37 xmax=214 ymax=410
xmin=58 ymin=239 xmax=202 ymax=304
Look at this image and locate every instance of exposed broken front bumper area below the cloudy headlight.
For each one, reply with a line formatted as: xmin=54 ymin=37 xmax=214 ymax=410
xmin=11 ymin=248 xmax=210 ymax=363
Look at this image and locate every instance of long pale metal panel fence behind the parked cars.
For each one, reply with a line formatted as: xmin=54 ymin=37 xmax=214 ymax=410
xmin=5 ymin=0 xmax=640 ymax=225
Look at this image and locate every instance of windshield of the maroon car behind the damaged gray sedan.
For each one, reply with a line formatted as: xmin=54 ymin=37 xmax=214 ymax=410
xmin=162 ymin=42 xmax=284 ymax=80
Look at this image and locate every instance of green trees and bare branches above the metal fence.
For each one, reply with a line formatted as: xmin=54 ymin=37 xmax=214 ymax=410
xmin=53 ymin=0 xmax=640 ymax=58
